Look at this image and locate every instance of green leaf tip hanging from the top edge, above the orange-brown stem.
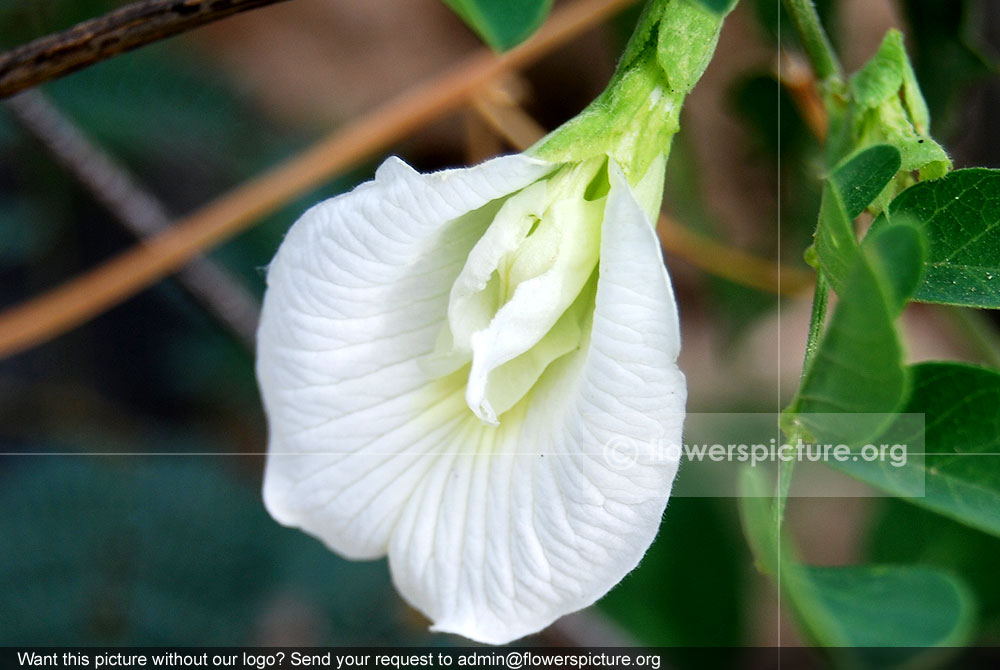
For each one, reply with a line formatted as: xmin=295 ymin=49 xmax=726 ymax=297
xmin=443 ymin=0 xmax=552 ymax=51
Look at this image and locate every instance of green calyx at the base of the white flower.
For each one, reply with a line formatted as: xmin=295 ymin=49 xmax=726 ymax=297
xmin=528 ymin=0 xmax=735 ymax=185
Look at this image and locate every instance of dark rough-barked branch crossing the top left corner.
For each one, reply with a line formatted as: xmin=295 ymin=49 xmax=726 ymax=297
xmin=0 ymin=0 xmax=285 ymax=97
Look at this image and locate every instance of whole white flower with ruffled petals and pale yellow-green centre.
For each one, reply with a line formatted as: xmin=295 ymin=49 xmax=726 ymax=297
xmin=257 ymin=155 xmax=685 ymax=643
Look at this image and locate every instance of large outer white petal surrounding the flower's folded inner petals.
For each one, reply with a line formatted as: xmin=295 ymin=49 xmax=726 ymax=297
xmin=258 ymin=156 xmax=685 ymax=643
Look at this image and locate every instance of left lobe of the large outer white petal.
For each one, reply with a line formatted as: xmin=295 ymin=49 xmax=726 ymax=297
xmin=257 ymin=156 xmax=552 ymax=558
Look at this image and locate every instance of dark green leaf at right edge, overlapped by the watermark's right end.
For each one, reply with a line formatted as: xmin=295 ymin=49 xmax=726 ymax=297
xmin=836 ymin=363 xmax=1000 ymax=535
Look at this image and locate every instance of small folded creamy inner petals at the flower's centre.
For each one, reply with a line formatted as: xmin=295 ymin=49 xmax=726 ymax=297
xmin=449 ymin=158 xmax=607 ymax=425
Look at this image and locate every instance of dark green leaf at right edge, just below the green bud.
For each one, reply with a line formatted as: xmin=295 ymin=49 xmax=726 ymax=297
xmin=876 ymin=168 xmax=1000 ymax=309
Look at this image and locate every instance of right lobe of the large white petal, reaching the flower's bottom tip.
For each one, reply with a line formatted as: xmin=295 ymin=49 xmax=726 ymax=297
xmin=389 ymin=160 xmax=686 ymax=644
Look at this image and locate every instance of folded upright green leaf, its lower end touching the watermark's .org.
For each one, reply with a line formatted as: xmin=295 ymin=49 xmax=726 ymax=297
xmin=784 ymin=225 xmax=924 ymax=445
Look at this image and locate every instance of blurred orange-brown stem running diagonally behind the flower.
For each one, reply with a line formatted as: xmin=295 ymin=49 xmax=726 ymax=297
xmin=0 ymin=0 xmax=635 ymax=358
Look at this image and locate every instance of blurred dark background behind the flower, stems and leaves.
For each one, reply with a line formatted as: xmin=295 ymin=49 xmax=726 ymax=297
xmin=0 ymin=0 xmax=1000 ymax=666
